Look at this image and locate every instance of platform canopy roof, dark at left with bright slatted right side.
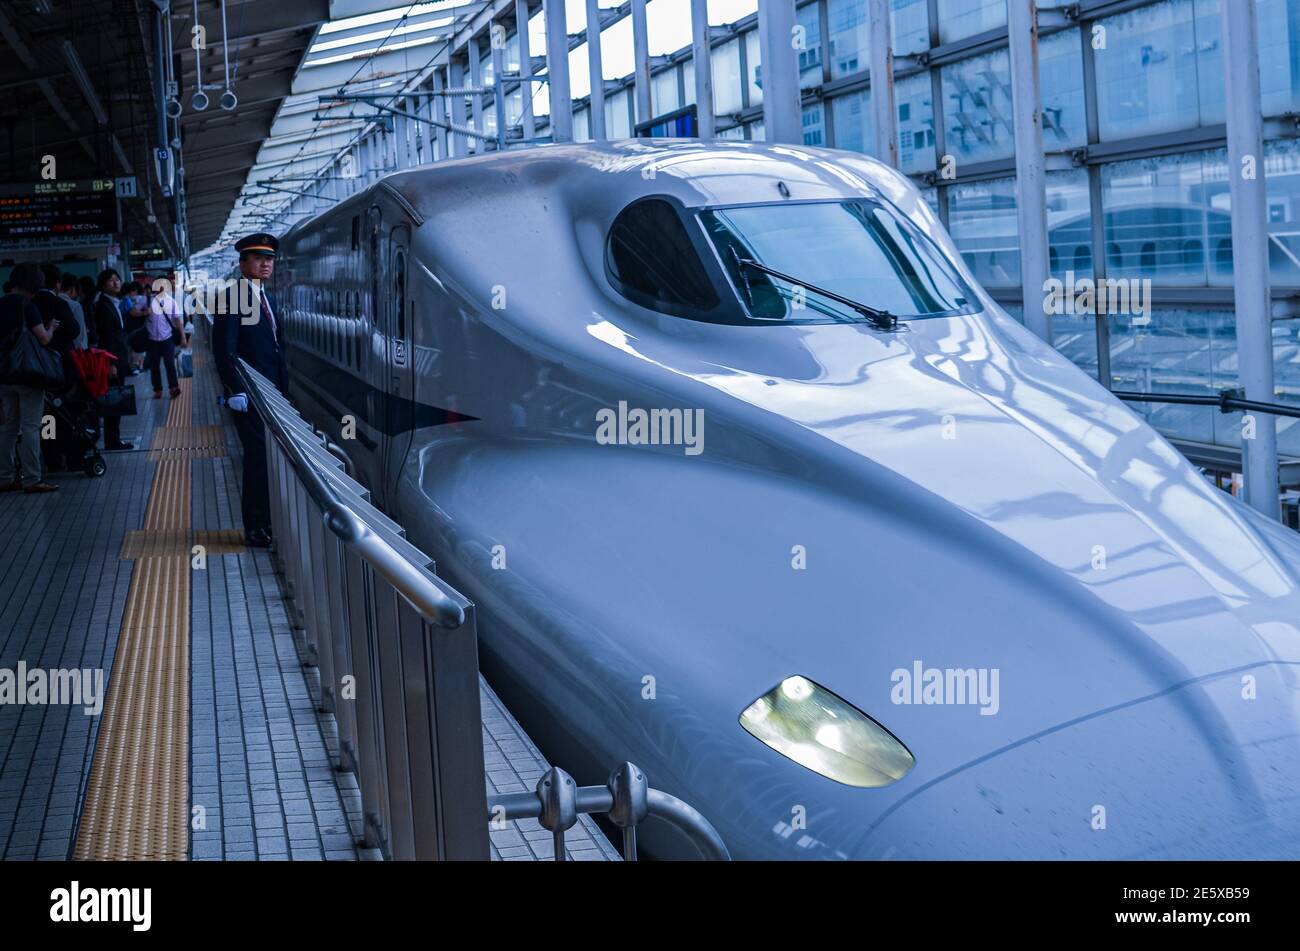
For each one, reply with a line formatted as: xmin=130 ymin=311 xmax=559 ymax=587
xmin=0 ymin=0 xmax=488 ymax=257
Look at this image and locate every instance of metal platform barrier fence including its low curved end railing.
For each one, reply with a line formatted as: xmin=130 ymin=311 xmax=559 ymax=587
xmin=238 ymin=360 xmax=728 ymax=860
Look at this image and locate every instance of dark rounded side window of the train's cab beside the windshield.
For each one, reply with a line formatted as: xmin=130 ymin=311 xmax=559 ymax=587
xmin=605 ymin=197 xmax=719 ymax=314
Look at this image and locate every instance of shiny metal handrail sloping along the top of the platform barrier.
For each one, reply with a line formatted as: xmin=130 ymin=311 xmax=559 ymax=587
xmin=235 ymin=359 xmax=465 ymax=629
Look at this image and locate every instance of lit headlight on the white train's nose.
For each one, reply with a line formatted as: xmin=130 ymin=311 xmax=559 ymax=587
xmin=740 ymin=676 xmax=917 ymax=789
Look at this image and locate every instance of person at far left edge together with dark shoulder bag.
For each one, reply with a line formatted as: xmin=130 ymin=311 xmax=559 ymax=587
xmin=0 ymin=262 xmax=61 ymax=494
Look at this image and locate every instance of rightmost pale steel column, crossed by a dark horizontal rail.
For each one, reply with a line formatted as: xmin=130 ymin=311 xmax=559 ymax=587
xmin=1221 ymin=0 xmax=1278 ymax=518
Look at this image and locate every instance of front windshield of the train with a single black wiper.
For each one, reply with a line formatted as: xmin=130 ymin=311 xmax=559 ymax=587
xmin=699 ymin=200 xmax=980 ymax=323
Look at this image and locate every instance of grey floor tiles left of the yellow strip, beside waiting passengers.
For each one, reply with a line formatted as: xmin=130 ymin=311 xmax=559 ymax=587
xmin=0 ymin=368 xmax=156 ymax=859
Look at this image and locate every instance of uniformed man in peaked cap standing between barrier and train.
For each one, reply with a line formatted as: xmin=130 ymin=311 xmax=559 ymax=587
xmin=212 ymin=233 xmax=289 ymax=548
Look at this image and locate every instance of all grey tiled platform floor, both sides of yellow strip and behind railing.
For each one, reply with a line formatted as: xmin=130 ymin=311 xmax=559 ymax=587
xmin=0 ymin=335 xmax=619 ymax=861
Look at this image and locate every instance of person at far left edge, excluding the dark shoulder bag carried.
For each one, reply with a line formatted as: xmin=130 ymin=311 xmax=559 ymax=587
xmin=0 ymin=262 xmax=59 ymax=494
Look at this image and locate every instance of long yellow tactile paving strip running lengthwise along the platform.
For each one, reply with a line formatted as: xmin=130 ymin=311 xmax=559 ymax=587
xmin=75 ymin=378 xmax=196 ymax=861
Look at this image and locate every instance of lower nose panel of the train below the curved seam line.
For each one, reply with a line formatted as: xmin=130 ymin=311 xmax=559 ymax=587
xmin=854 ymin=664 xmax=1300 ymax=859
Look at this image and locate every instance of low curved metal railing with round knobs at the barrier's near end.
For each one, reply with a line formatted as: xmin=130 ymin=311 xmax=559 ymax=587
xmin=488 ymin=763 xmax=731 ymax=861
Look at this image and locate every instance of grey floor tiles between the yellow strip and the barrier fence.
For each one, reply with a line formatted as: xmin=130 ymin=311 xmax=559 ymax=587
xmin=190 ymin=353 xmax=359 ymax=860
